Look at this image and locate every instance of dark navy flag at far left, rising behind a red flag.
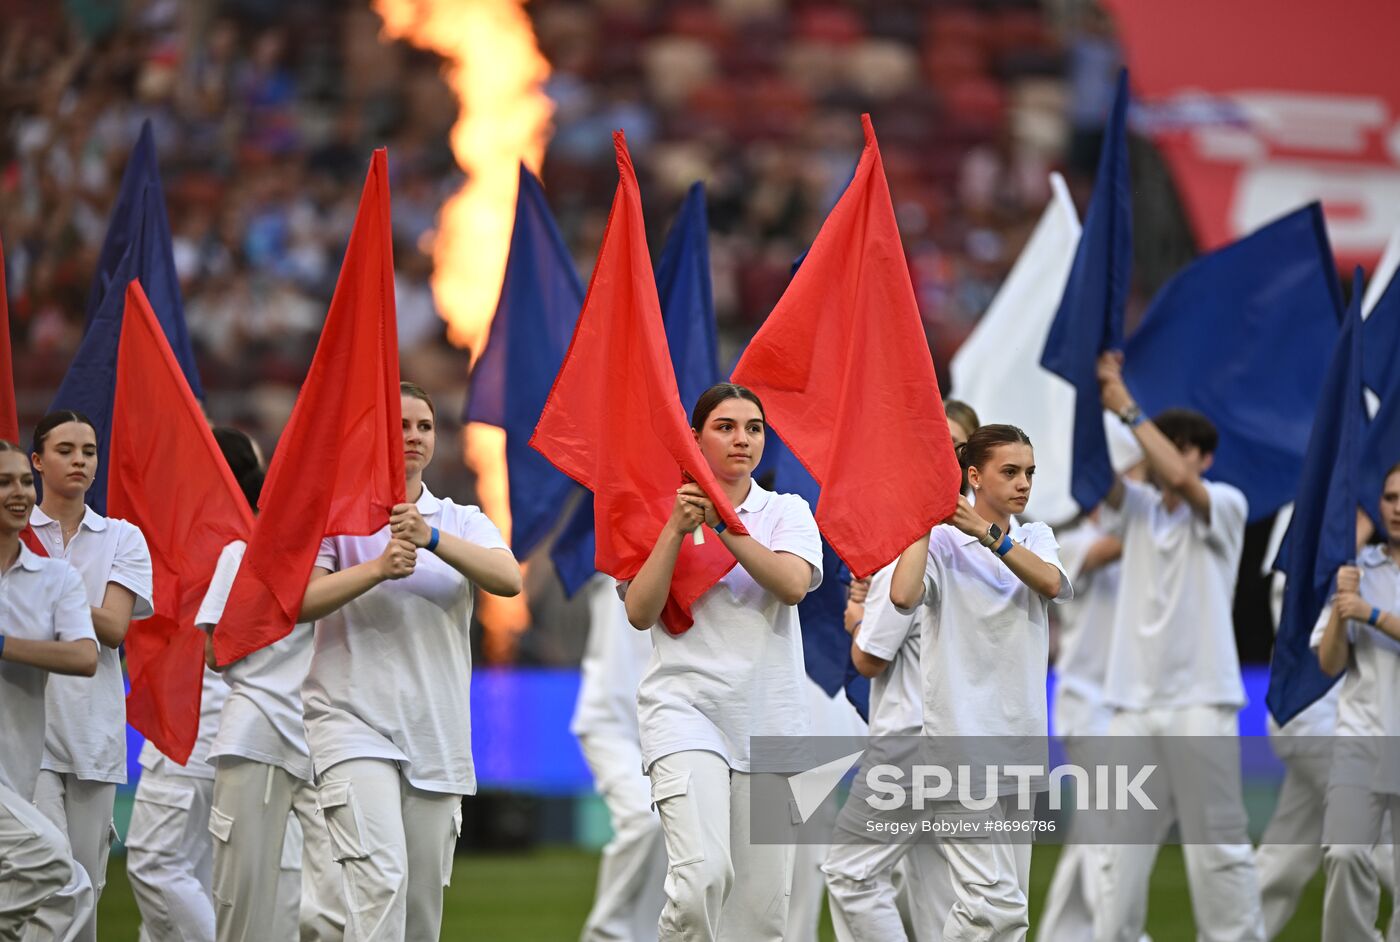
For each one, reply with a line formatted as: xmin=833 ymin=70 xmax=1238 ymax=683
xmin=49 ymin=122 xmax=204 ymax=514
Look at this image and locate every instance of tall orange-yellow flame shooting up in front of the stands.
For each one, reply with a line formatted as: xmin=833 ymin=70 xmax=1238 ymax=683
xmin=374 ymin=0 xmax=553 ymax=661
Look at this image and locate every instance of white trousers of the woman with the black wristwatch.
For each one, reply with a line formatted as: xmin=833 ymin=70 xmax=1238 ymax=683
xmin=822 ymin=796 xmax=1030 ymax=942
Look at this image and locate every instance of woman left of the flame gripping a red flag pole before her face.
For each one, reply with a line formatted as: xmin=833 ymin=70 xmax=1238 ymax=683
xmin=298 ymin=382 xmax=521 ymax=939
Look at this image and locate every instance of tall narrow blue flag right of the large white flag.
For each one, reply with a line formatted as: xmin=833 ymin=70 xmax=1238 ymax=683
xmin=1040 ymin=70 xmax=1133 ymax=511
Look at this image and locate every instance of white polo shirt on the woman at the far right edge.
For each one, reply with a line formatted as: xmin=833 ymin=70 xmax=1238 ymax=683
xmin=1310 ymin=546 xmax=1400 ymax=795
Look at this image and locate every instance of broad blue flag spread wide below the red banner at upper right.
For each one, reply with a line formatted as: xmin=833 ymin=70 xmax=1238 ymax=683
xmin=1123 ymin=203 xmax=1341 ymax=521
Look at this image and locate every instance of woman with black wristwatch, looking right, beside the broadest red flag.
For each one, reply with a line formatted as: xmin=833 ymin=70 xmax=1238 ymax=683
xmin=873 ymin=426 xmax=1072 ymax=942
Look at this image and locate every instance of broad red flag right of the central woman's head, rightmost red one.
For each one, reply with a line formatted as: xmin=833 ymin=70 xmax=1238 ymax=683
xmin=734 ymin=115 xmax=960 ymax=578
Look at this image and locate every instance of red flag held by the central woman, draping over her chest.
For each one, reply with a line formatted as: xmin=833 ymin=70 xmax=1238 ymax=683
xmin=529 ymin=132 xmax=748 ymax=634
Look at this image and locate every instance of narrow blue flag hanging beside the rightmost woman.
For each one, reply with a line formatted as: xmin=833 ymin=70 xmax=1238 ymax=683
xmin=1267 ymin=269 xmax=1366 ymax=724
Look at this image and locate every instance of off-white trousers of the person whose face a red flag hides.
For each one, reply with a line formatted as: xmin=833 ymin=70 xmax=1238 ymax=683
xmin=209 ymin=757 xmax=346 ymax=942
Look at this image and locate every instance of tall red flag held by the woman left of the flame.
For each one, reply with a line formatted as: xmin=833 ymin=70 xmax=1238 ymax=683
xmin=214 ymin=148 xmax=405 ymax=663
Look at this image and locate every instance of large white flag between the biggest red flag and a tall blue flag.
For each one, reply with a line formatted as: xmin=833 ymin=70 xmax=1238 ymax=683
xmin=951 ymin=174 xmax=1081 ymax=523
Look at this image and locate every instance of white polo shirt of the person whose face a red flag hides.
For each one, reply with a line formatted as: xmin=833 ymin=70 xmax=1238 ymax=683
xmin=203 ymin=540 xmax=315 ymax=781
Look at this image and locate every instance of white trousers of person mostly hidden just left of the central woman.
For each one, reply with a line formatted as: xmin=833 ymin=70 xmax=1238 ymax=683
xmin=578 ymin=731 xmax=666 ymax=942
